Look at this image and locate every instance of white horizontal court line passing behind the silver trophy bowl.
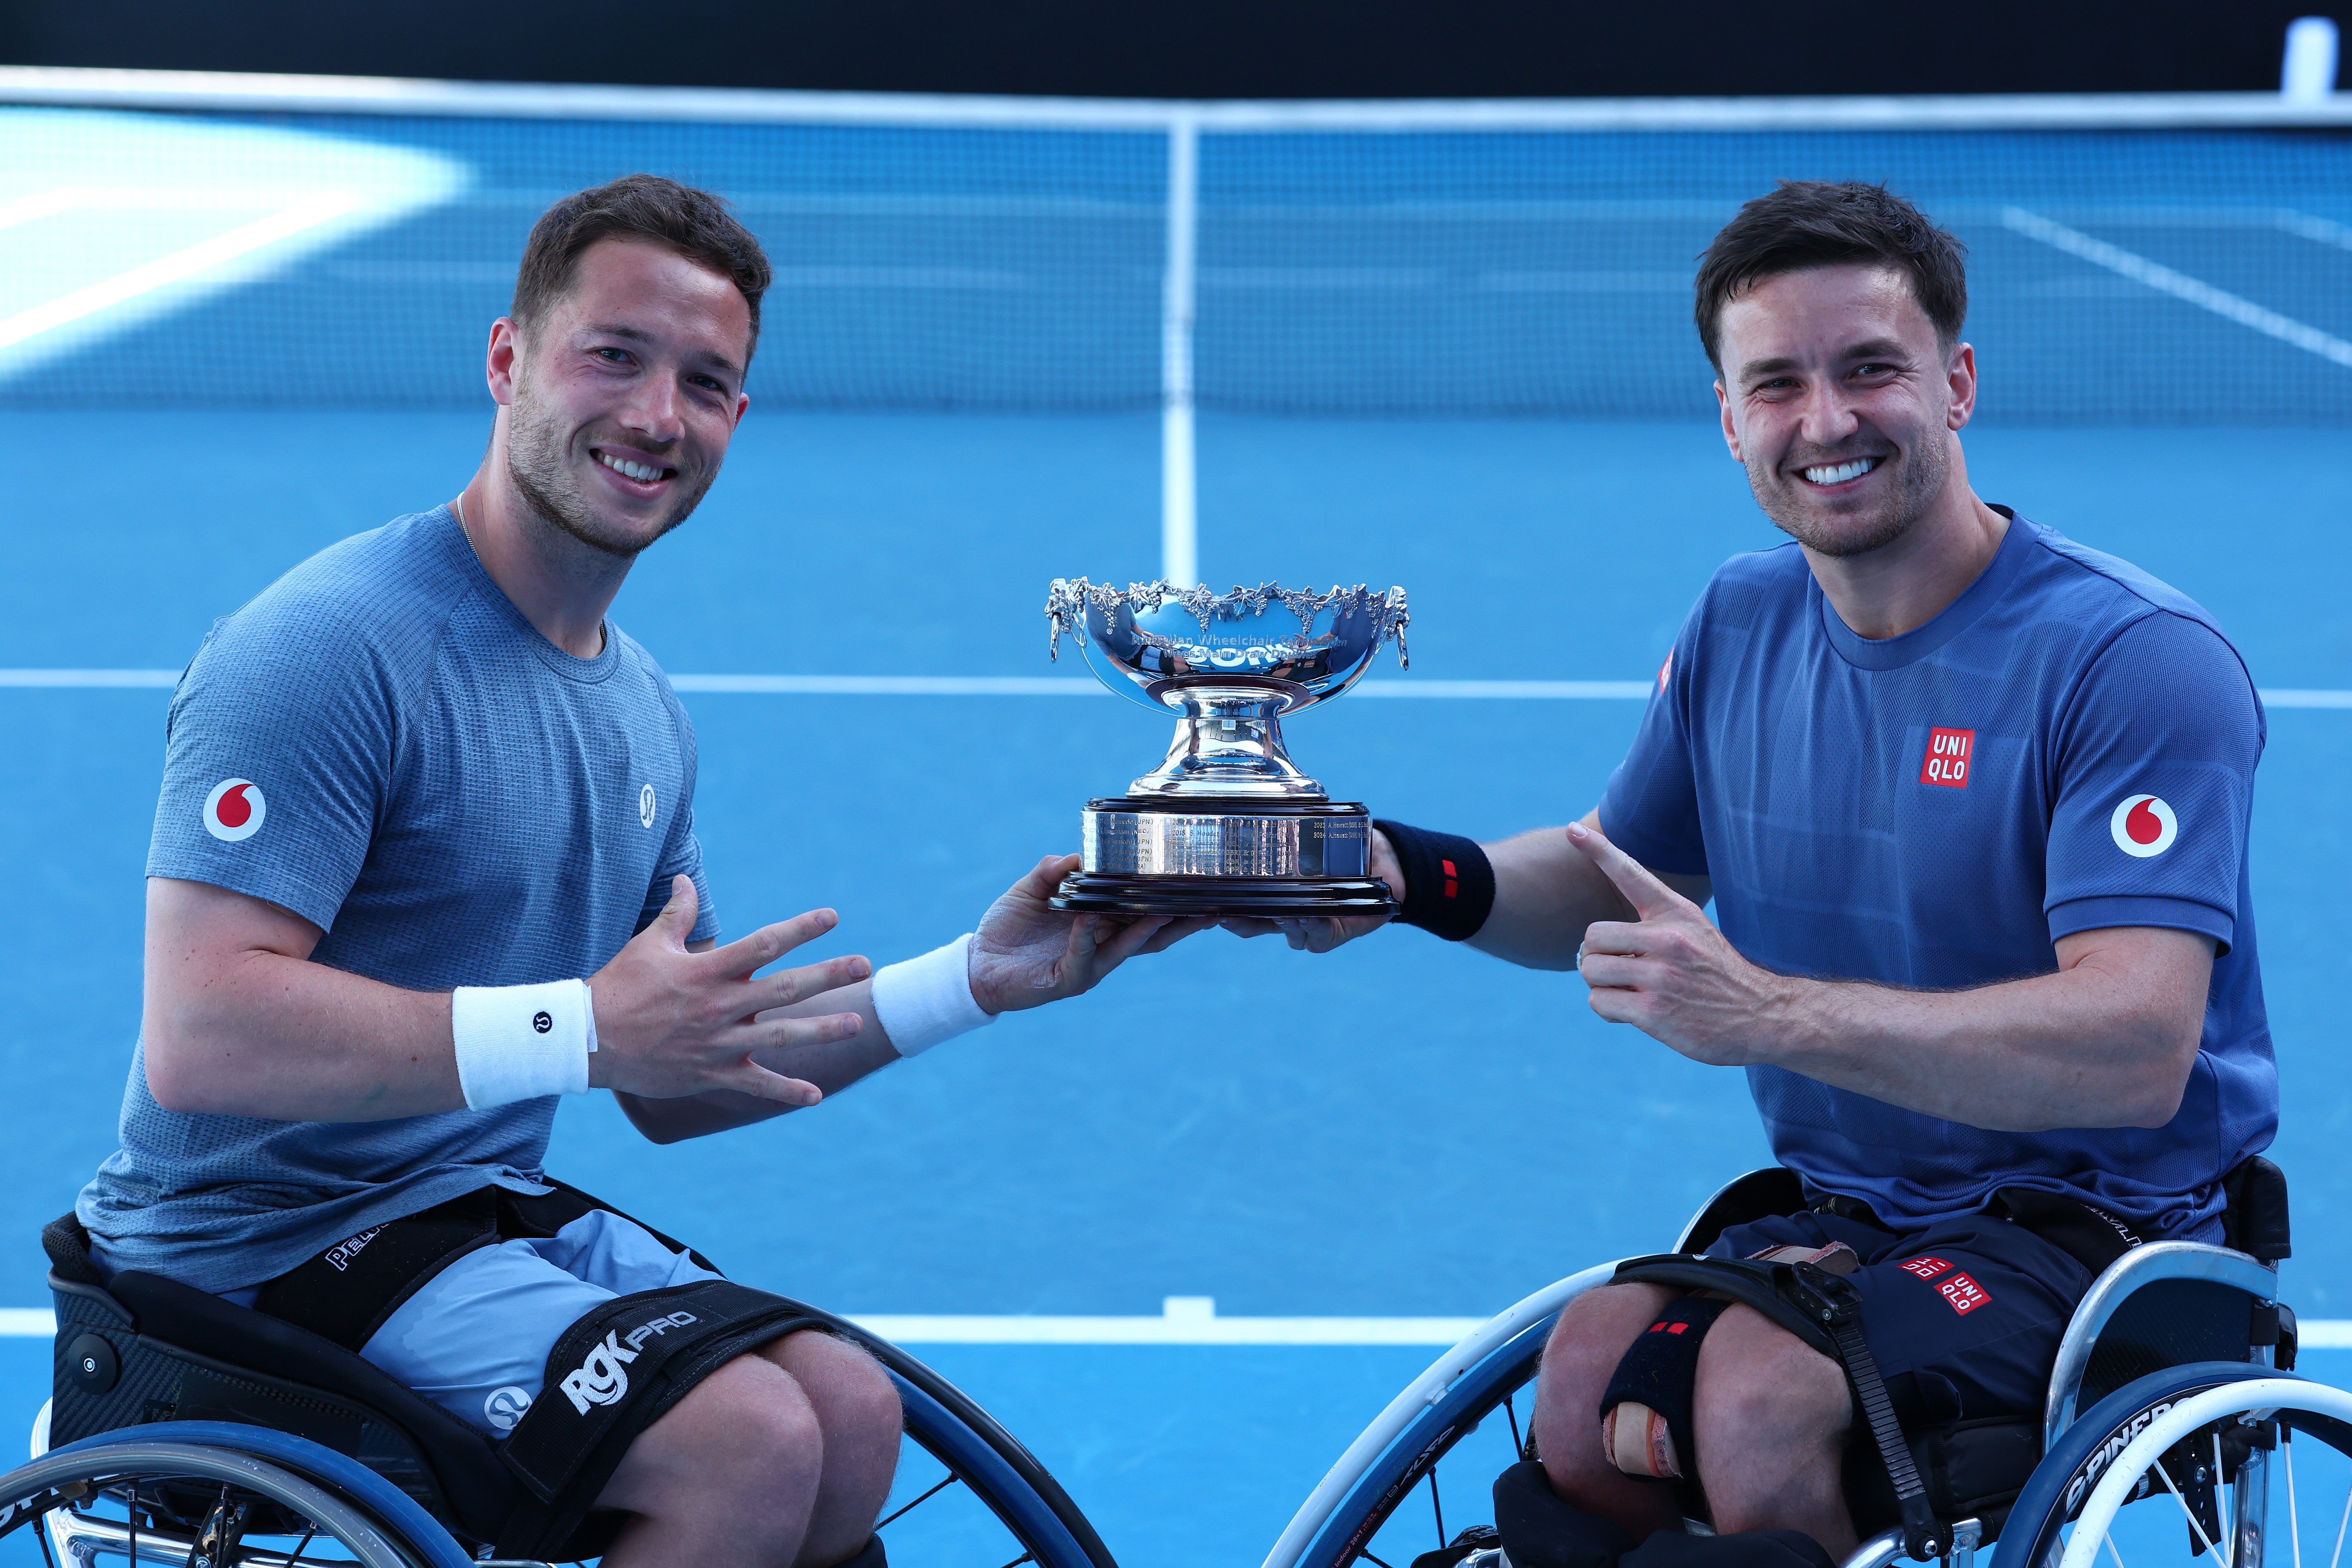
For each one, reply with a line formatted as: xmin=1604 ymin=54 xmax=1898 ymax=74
xmin=14 ymin=670 xmax=2352 ymax=707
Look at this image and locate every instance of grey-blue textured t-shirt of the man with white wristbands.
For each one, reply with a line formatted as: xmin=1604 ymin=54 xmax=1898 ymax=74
xmin=78 ymin=508 xmax=717 ymax=1291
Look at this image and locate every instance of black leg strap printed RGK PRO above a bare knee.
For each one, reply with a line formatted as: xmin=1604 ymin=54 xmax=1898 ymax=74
xmin=496 ymin=1279 xmax=821 ymax=1559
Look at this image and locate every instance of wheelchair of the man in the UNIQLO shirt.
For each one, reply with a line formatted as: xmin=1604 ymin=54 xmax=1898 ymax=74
xmin=1266 ymin=1159 xmax=2352 ymax=1568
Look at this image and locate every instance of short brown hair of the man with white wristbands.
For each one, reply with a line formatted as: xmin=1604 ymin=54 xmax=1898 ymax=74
xmin=510 ymin=174 xmax=771 ymax=367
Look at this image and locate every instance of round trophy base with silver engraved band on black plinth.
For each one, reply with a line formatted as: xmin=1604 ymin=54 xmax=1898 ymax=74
xmin=1051 ymin=795 xmax=1397 ymax=919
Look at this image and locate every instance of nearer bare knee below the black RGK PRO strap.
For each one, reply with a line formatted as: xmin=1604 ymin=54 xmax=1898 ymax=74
xmin=597 ymin=1356 xmax=826 ymax=1568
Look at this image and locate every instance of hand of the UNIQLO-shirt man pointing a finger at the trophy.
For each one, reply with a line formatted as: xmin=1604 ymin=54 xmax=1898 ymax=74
xmin=1569 ymin=823 xmax=1795 ymax=1067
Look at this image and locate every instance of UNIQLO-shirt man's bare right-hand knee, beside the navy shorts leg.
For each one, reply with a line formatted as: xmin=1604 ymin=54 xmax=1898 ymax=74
xmin=1693 ymin=1305 xmax=1856 ymax=1559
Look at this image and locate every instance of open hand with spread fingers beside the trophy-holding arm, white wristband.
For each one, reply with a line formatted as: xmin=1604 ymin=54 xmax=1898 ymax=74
xmin=588 ymin=877 xmax=873 ymax=1105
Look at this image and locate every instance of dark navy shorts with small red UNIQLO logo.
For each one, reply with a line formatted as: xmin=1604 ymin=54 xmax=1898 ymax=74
xmin=1708 ymin=1213 xmax=2091 ymax=1422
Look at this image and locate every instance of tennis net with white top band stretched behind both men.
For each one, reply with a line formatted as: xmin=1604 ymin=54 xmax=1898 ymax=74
xmin=0 ymin=68 xmax=2352 ymax=426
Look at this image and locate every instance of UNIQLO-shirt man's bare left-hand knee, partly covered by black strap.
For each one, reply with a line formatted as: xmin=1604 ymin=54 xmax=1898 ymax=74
xmin=1529 ymin=1286 xmax=1693 ymax=1540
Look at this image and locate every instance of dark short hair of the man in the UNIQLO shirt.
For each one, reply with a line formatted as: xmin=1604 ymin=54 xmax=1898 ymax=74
xmin=1698 ymin=179 xmax=1969 ymax=371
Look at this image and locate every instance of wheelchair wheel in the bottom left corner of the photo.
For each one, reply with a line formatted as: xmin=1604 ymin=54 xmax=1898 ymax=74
xmin=0 ymin=1422 xmax=473 ymax=1568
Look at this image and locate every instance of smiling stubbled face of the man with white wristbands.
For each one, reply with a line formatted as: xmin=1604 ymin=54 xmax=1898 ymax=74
xmin=492 ymin=240 xmax=750 ymax=557
